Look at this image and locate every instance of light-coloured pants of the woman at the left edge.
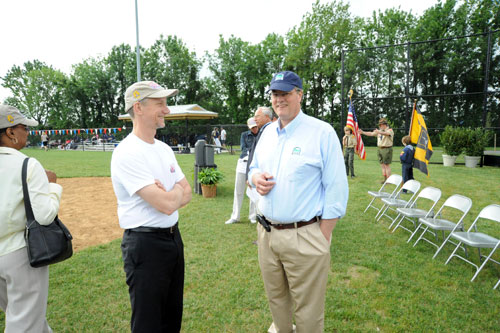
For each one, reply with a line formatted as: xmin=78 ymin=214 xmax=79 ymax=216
xmin=0 ymin=247 xmax=52 ymax=333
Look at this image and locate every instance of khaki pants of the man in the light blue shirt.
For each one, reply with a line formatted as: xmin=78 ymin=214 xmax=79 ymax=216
xmin=257 ymin=223 xmax=330 ymax=333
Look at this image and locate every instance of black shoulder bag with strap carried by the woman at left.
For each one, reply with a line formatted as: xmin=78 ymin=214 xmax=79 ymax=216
xmin=22 ymin=157 xmax=73 ymax=267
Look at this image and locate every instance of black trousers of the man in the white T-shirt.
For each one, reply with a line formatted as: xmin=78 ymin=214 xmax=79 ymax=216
xmin=121 ymin=229 xmax=184 ymax=333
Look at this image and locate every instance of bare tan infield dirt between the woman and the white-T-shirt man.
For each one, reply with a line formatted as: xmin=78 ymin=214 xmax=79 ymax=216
xmin=57 ymin=177 xmax=123 ymax=251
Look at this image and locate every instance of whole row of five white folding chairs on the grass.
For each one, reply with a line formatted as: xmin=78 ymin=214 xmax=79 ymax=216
xmin=364 ymin=174 xmax=500 ymax=289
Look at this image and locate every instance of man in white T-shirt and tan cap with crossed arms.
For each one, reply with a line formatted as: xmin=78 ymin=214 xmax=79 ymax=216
xmin=111 ymin=81 xmax=191 ymax=332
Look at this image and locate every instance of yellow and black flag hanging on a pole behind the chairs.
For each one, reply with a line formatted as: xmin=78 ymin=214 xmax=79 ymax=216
xmin=410 ymin=102 xmax=432 ymax=177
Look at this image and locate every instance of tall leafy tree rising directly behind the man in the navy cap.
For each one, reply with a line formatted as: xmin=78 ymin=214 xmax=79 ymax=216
xmin=285 ymin=1 xmax=356 ymax=122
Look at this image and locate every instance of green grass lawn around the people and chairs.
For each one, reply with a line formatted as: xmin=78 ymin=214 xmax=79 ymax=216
xmin=0 ymin=148 xmax=500 ymax=332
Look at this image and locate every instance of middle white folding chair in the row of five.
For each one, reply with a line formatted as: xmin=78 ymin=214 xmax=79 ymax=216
xmin=389 ymin=186 xmax=441 ymax=243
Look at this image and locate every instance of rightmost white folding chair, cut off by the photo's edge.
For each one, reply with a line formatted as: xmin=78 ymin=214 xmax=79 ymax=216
xmin=445 ymin=204 xmax=500 ymax=289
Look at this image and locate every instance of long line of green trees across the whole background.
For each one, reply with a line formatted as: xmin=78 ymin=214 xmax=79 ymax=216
xmin=1 ymin=0 xmax=500 ymax=129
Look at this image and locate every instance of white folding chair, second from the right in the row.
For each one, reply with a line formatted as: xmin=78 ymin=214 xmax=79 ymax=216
xmin=413 ymin=194 xmax=472 ymax=259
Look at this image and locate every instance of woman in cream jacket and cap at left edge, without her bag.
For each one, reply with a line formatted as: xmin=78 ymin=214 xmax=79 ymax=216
xmin=0 ymin=105 xmax=62 ymax=332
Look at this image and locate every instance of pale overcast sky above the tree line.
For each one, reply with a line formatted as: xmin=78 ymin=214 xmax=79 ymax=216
xmin=0 ymin=0 xmax=437 ymax=101
